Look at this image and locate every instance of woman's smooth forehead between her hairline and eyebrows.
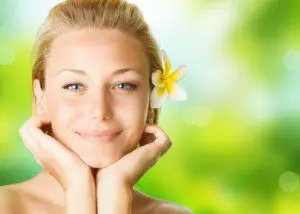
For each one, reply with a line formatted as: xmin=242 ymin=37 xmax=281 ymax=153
xmin=46 ymin=28 xmax=149 ymax=78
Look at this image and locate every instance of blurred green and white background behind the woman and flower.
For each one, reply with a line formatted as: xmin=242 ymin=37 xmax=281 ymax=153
xmin=0 ymin=0 xmax=300 ymax=214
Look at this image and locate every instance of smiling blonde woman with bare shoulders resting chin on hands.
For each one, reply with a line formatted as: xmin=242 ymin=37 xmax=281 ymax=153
xmin=0 ymin=0 xmax=191 ymax=214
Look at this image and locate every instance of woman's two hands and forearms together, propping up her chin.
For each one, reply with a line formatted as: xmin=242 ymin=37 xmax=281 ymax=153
xmin=20 ymin=117 xmax=172 ymax=214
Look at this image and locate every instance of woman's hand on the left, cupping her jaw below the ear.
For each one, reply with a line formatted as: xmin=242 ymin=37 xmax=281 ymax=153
xmin=19 ymin=116 xmax=93 ymax=190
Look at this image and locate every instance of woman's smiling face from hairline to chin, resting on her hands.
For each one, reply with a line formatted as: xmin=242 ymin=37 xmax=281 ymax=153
xmin=34 ymin=29 xmax=150 ymax=168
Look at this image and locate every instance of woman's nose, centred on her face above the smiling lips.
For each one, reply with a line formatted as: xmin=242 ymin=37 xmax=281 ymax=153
xmin=88 ymin=91 xmax=113 ymax=121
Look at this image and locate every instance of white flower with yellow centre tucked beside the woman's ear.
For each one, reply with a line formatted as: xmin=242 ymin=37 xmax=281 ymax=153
xmin=151 ymin=50 xmax=187 ymax=108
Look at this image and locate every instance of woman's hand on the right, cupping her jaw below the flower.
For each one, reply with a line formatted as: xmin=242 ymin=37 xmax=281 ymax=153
xmin=97 ymin=125 xmax=172 ymax=188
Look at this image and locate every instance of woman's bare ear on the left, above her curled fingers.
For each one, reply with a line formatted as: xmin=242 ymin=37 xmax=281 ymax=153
xmin=32 ymin=79 xmax=48 ymax=116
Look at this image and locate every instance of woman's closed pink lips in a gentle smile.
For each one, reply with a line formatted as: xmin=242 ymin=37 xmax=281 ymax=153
xmin=76 ymin=131 xmax=122 ymax=143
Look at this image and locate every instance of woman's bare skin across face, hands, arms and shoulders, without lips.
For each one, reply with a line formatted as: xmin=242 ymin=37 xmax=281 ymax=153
xmin=0 ymin=29 xmax=192 ymax=214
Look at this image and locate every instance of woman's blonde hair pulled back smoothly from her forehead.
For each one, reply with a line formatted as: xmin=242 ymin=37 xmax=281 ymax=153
xmin=32 ymin=0 xmax=162 ymax=124
